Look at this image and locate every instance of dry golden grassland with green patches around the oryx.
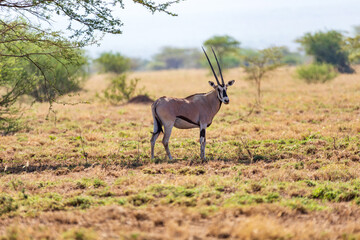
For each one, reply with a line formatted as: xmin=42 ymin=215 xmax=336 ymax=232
xmin=0 ymin=68 xmax=360 ymax=239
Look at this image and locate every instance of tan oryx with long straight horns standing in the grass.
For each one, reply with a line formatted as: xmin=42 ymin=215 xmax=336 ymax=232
xmin=151 ymin=48 xmax=235 ymax=160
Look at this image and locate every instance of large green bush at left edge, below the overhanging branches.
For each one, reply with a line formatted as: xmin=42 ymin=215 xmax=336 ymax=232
xmin=0 ymin=21 xmax=87 ymax=102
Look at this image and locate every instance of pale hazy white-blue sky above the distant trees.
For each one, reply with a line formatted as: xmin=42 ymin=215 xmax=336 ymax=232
xmin=82 ymin=0 xmax=360 ymax=59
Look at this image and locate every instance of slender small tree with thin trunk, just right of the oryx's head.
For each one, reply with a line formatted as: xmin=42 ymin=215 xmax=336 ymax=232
xmin=244 ymin=47 xmax=283 ymax=108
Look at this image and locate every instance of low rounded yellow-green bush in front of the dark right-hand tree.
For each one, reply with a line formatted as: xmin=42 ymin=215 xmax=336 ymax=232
xmin=296 ymin=63 xmax=337 ymax=83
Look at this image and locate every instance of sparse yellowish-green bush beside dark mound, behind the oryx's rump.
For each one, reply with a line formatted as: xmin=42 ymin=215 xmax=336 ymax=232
xmin=104 ymin=74 xmax=140 ymax=104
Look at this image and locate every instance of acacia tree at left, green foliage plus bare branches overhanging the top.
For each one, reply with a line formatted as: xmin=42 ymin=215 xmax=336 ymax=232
xmin=0 ymin=0 xmax=181 ymax=131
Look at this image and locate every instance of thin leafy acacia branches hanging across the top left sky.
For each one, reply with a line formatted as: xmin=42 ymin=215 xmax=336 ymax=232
xmin=0 ymin=0 xmax=181 ymax=45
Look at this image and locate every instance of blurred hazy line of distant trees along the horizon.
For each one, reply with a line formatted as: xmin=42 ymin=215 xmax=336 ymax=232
xmin=95 ymin=30 xmax=360 ymax=74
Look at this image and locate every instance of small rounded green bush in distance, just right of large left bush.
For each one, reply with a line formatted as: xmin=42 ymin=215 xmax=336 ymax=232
xmin=95 ymin=52 xmax=131 ymax=74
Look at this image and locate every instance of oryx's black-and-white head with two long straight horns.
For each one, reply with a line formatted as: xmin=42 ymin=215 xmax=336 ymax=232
xmin=202 ymin=48 xmax=235 ymax=104
